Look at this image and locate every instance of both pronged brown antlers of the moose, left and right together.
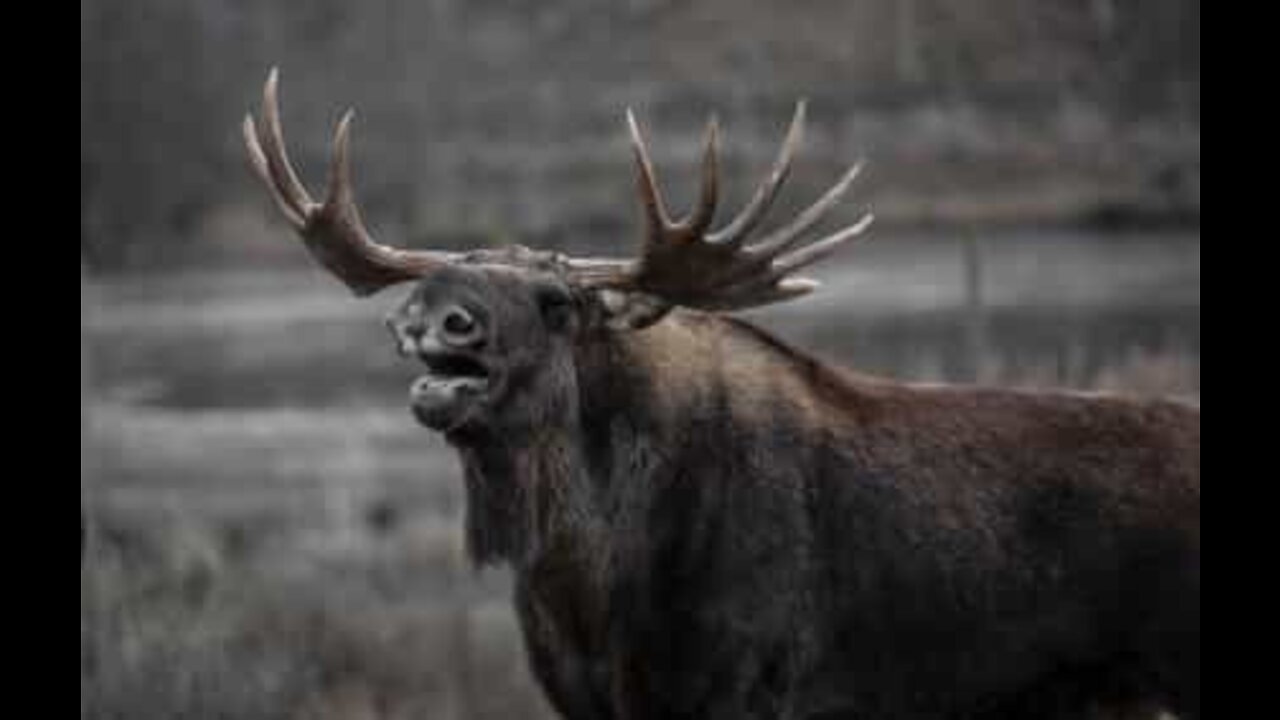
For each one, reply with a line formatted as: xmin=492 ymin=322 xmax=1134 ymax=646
xmin=243 ymin=68 xmax=872 ymax=310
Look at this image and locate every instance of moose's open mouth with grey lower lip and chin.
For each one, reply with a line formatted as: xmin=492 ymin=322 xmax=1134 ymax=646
xmin=410 ymin=352 xmax=493 ymax=432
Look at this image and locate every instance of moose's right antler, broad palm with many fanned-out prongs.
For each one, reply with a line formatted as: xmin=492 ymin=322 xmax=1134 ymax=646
xmin=570 ymin=101 xmax=872 ymax=310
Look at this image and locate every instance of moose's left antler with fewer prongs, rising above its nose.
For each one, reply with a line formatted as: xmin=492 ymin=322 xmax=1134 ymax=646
xmin=243 ymin=68 xmax=460 ymax=297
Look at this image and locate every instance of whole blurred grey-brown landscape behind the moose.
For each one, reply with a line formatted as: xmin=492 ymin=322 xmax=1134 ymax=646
xmin=81 ymin=0 xmax=1201 ymax=720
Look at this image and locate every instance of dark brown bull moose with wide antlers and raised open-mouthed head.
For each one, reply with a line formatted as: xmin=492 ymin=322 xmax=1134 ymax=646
xmin=243 ymin=70 xmax=1201 ymax=720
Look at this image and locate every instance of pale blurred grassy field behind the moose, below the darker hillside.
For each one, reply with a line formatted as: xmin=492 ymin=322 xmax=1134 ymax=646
xmin=81 ymin=234 xmax=1199 ymax=720
